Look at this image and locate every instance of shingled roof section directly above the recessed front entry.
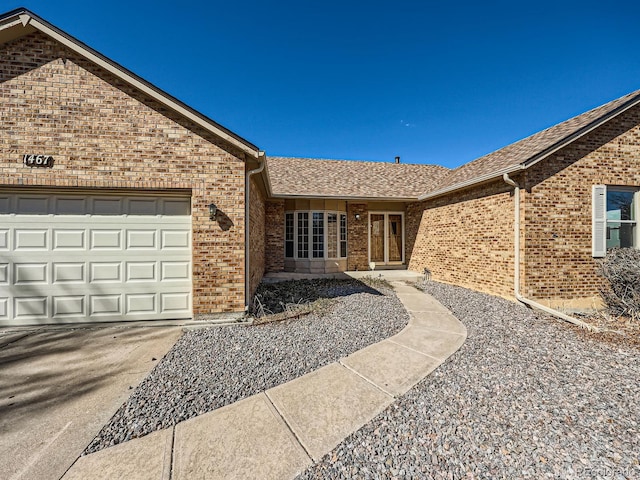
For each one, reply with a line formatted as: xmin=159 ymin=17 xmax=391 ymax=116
xmin=267 ymin=157 xmax=450 ymax=199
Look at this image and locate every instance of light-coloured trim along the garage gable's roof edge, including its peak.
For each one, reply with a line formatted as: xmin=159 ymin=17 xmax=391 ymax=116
xmin=0 ymin=10 xmax=259 ymax=158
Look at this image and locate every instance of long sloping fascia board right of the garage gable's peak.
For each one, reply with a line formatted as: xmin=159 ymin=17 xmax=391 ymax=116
xmin=17 ymin=14 xmax=259 ymax=158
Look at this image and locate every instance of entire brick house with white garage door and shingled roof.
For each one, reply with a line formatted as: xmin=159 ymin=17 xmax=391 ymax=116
xmin=0 ymin=9 xmax=640 ymax=326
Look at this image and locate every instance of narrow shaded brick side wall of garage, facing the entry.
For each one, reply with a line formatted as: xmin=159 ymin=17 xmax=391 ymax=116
xmin=249 ymin=175 xmax=265 ymax=298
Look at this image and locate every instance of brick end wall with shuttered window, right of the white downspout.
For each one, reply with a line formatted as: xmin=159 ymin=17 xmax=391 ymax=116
xmin=523 ymin=103 xmax=640 ymax=299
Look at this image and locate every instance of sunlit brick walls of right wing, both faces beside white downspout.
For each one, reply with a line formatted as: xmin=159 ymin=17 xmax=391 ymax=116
xmin=407 ymin=103 xmax=640 ymax=307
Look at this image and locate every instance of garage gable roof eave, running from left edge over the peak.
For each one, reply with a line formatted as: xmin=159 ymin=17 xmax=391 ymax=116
xmin=0 ymin=8 xmax=260 ymax=159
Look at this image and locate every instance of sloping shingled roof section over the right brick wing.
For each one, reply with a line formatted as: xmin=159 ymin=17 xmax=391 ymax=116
xmin=423 ymin=90 xmax=640 ymax=197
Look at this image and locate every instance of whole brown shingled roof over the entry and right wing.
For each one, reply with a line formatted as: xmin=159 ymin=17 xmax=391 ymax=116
xmin=267 ymin=90 xmax=640 ymax=199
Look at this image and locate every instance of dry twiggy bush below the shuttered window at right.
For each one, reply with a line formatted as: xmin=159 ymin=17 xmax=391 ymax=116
xmin=599 ymin=248 xmax=640 ymax=321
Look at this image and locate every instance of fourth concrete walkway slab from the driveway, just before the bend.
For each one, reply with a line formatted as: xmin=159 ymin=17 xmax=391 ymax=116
xmin=341 ymin=340 xmax=442 ymax=397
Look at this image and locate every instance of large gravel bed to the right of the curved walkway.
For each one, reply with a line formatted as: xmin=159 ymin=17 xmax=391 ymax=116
xmin=298 ymin=282 xmax=640 ymax=479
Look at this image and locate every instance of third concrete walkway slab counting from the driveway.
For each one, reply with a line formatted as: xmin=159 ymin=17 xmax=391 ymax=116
xmin=267 ymin=363 xmax=393 ymax=461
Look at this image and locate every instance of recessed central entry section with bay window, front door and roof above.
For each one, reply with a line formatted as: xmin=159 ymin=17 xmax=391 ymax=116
xmin=264 ymin=157 xmax=449 ymax=273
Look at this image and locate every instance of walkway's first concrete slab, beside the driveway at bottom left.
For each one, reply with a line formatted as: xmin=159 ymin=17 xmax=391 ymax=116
xmin=62 ymin=428 xmax=173 ymax=480
